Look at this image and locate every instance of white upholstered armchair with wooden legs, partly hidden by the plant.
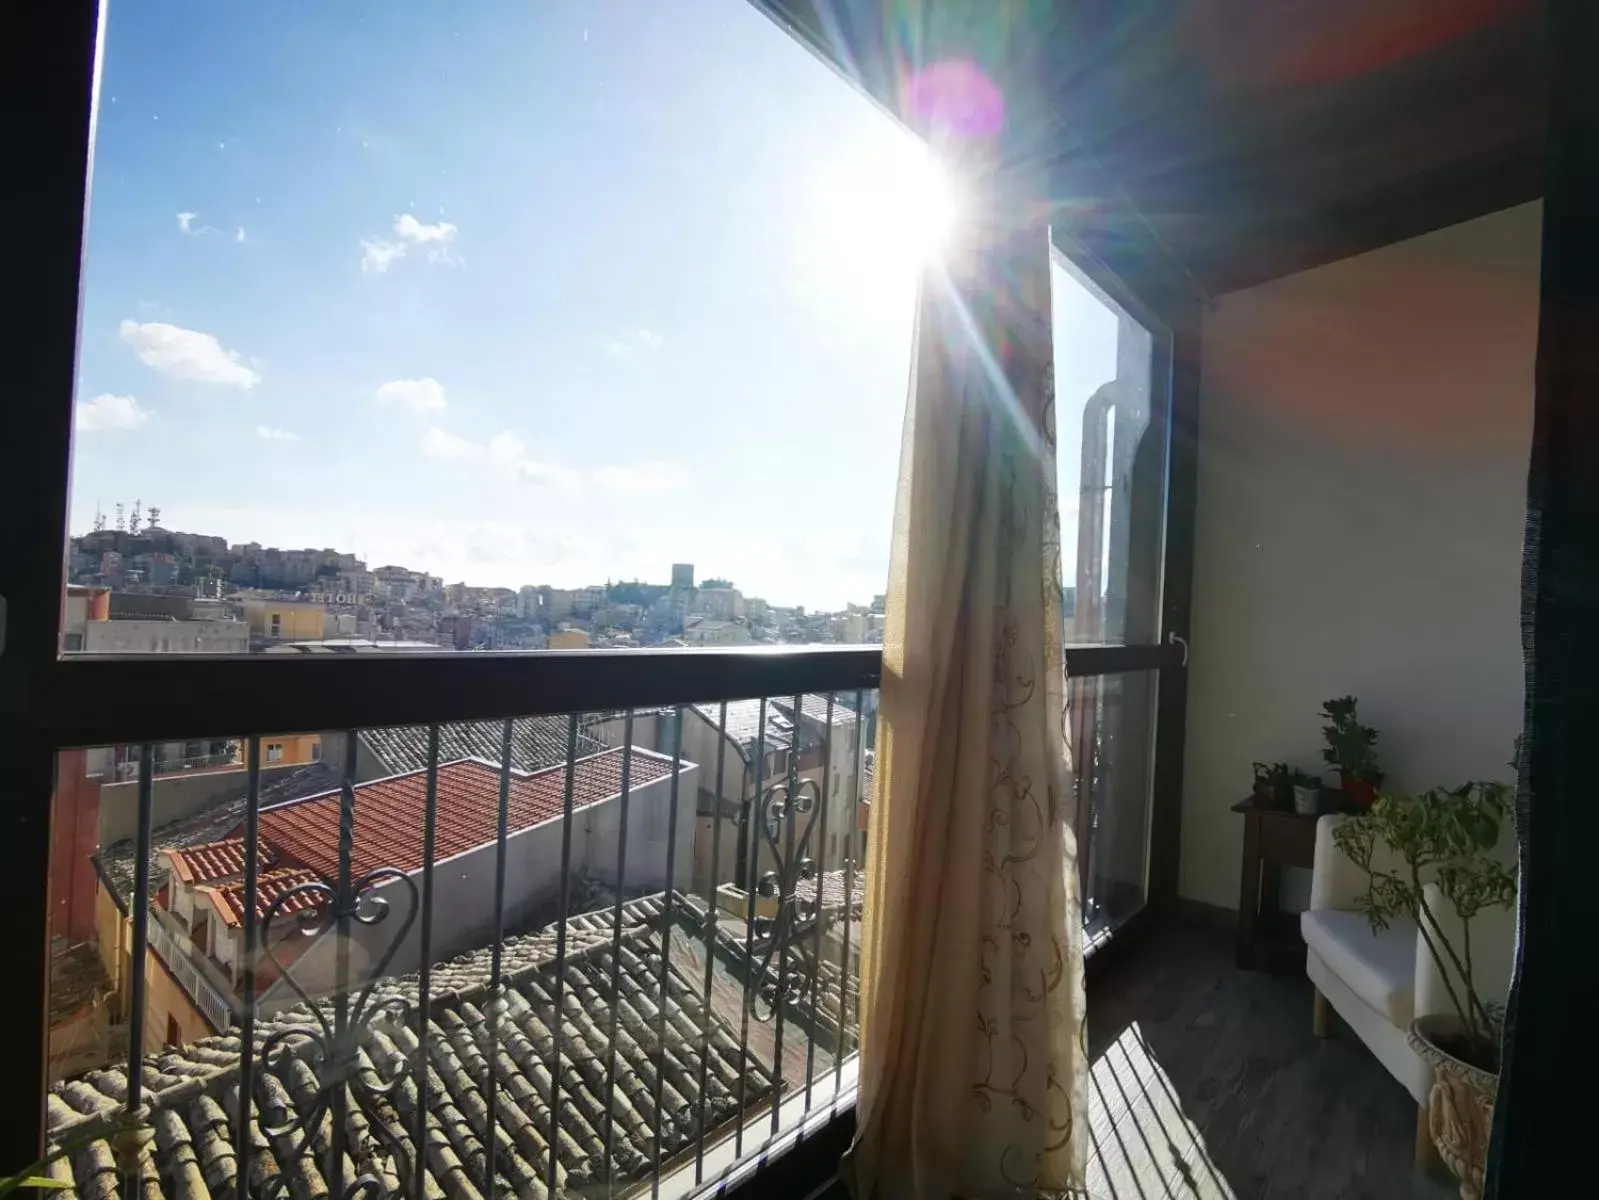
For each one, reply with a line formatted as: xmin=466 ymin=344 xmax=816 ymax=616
xmin=1300 ymin=816 xmax=1516 ymax=1160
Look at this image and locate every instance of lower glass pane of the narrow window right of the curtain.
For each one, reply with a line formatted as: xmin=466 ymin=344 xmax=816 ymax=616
xmin=1067 ymin=670 xmax=1159 ymax=938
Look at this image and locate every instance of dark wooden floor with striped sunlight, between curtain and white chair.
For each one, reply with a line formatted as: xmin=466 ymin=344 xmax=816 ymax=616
xmin=1089 ymin=926 xmax=1457 ymax=1200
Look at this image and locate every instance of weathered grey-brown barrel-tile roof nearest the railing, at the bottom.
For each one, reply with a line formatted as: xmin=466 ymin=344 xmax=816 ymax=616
xmin=46 ymin=896 xmax=772 ymax=1200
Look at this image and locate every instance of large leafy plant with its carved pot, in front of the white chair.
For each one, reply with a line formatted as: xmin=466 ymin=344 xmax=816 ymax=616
xmin=1334 ymin=782 xmax=1516 ymax=1200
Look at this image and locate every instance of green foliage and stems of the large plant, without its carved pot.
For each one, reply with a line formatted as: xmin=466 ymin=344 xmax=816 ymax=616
xmin=1332 ymin=782 xmax=1516 ymax=1070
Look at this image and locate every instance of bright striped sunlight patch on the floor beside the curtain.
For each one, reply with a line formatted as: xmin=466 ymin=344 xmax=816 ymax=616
xmin=1089 ymin=1021 xmax=1238 ymax=1200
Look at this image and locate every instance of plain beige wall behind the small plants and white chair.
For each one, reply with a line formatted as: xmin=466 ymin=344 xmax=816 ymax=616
xmin=1178 ymin=205 xmax=1540 ymax=907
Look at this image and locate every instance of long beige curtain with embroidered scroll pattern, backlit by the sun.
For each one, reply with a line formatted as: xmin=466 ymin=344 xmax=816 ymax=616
xmin=844 ymin=222 xmax=1087 ymax=1200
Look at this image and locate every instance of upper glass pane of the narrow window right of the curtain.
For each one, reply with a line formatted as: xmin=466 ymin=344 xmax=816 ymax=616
xmin=1051 ymin=251 xmax=1167 ymax=645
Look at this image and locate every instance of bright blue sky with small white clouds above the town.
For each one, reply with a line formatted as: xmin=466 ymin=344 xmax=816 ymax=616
xmin=72 ymin=0 xmax=1115 ymax=608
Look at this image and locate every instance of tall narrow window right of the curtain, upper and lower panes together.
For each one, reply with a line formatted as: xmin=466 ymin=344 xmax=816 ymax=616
xmin=1051 ymin=242 xmax=1185 ymax=942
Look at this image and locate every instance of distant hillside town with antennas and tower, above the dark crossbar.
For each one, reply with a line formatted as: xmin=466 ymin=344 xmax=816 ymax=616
xmin=62 ymin=502 xmax=884 ymax=654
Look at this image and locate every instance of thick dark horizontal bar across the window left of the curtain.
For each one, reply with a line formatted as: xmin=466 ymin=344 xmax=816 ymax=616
xmin=32 ymin=646 xmax=883 ymax=749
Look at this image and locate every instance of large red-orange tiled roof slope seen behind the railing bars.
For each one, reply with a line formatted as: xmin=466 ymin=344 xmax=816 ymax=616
xmin=261 ymin=749 xmax=672 ymax=878
